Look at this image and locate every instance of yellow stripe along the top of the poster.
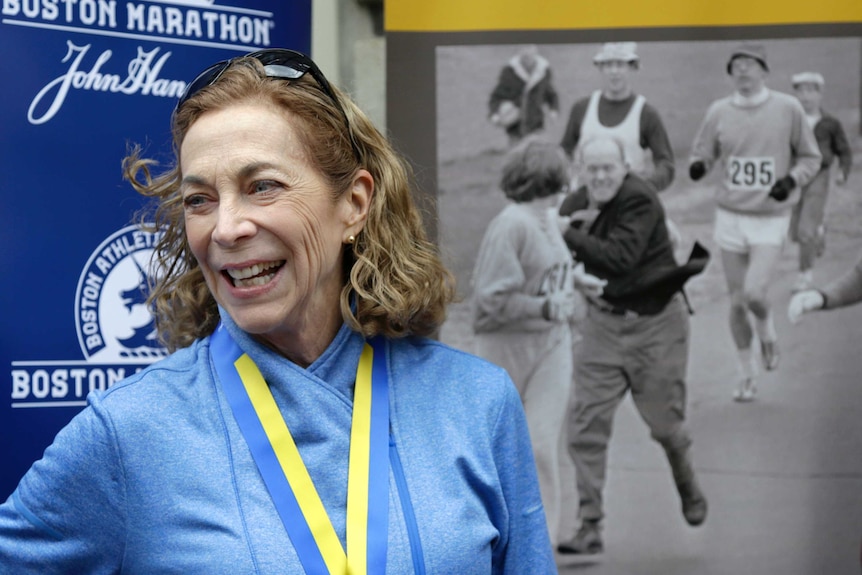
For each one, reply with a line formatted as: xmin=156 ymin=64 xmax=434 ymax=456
xmin=385 ymin=0 xmax=862 ymax=32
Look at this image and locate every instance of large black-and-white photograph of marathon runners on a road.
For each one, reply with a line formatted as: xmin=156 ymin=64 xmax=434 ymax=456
xmin=434 ymin=36 xmax=862 ymax=574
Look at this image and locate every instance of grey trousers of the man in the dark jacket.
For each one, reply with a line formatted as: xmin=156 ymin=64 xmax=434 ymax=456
xmin=567 ymin=295 xmax=691 ymax=520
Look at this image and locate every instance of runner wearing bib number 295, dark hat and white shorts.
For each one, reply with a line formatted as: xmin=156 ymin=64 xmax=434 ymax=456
xmin=689 ymin=44 xmax=821 ymax=401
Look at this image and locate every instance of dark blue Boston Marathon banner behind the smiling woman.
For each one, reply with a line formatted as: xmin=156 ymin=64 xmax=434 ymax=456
xmin=0 ymin=0 xmax=311 ymax=500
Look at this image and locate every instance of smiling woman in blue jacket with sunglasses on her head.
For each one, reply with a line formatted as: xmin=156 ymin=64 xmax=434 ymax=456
xmin=0 ymin=50 xmax=556 ymax=575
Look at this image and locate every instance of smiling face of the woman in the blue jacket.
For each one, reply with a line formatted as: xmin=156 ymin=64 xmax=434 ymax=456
xmin=180 ymin=103 xmax=373 ymax=357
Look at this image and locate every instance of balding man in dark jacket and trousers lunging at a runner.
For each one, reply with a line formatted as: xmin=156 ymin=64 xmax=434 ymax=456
xmin=558 ymin=136 xmax=708 ymax=554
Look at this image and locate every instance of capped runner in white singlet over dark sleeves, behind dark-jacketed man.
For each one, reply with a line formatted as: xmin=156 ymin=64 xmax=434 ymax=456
xmin=560 ymin=42 xmax=674 ymax=192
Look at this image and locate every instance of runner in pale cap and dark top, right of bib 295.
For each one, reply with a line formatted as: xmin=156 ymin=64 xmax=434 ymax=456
xmin=790 ymin=72 xmax=853 ymax=292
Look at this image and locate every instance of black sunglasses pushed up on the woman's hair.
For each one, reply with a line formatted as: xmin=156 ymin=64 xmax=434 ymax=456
xmin=174 ymin=48 xmax=362 ymax=161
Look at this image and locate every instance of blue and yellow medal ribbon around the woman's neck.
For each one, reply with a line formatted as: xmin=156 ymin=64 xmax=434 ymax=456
xmin=211 ymin=329 xmax=389 ymax=575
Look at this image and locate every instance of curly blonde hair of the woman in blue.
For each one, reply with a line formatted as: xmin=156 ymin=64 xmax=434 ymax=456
xmin=123 ymin=58 xmax=455 ymax=351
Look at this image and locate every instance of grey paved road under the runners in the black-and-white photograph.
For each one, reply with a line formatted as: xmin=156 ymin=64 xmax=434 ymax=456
xmin=559 ymin=240 xmax=862 ymax=575
